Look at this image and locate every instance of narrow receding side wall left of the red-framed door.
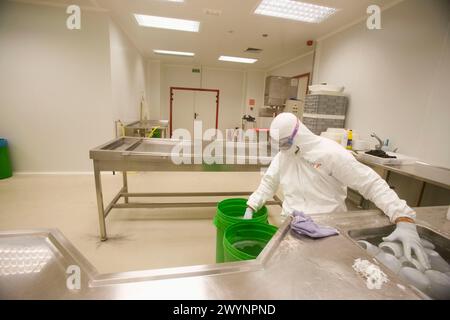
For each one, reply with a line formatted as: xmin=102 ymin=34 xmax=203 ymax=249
xmin=109 ymin=21 xmax=148 ymax=122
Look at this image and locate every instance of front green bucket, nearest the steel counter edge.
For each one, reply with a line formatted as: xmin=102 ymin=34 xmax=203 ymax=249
xmin=223 ymin=222 xmax=278 ymax=262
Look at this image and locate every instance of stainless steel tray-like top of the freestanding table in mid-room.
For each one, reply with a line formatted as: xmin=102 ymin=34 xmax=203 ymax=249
xmin=89 ymin=137 xmax=272 ymax=171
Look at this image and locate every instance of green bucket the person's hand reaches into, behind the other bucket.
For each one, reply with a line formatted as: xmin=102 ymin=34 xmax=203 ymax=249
xmin=214 ymin=199 xmax=269 ymax=263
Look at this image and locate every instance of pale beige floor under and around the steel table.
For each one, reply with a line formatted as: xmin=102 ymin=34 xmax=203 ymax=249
xmin=0 ymin=172 xmax=280 ymax=273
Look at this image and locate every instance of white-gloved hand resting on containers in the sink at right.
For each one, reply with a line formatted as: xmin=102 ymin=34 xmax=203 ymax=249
xmin=383 ymin=222 xmax=431 ymax=270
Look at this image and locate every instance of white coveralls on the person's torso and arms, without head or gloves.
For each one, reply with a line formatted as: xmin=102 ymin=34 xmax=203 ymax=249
xmin=247 ymin=119 xmax=415 ymax=222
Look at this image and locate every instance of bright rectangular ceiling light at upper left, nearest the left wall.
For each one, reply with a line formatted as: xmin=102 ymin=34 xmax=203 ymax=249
xmin=134 ymin=14 xmax=200 ymax=32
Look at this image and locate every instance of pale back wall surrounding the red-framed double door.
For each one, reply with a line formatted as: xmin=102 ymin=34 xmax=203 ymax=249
xmin=160 ymin=65 xmax=265 ymax=130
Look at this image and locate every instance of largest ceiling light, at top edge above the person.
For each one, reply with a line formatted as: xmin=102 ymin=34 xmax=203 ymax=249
xmin=255 ymin=0 xmax=337 ymax=23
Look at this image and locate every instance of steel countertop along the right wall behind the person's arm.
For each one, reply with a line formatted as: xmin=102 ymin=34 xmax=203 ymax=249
xmin=356 ymin=156 xmax=450 ymax=189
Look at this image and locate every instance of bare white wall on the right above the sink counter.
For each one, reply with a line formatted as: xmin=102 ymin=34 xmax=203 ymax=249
xmin=314 ymin=0 xmax=450 ymax=167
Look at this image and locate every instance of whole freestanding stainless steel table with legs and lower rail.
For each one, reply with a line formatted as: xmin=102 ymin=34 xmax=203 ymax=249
xmin=90 ymin=137 xmax=282 ymax=241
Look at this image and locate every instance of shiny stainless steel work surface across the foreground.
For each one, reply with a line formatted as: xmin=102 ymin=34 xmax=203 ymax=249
xmin=0 ymin=207 xmax=450 ymax=299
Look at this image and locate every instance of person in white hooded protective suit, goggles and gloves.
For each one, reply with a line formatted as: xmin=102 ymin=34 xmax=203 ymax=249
xmin=244 ymin=113 xmax=430 ymax=269
